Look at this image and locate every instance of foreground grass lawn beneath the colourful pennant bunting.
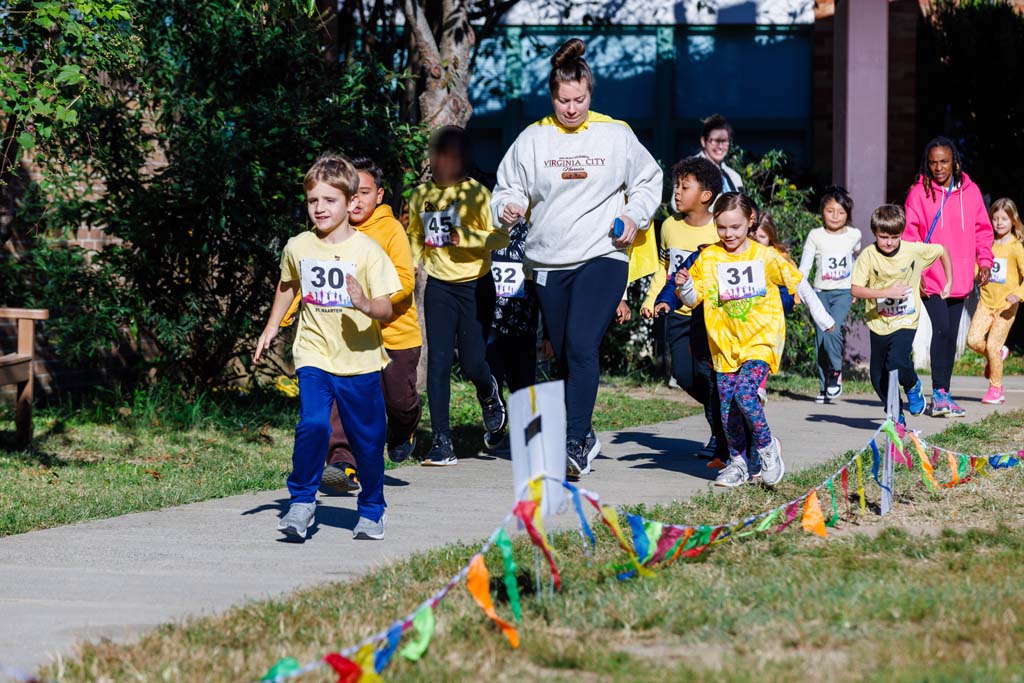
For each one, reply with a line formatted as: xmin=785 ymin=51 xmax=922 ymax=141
xmin=44 ymin=411 xmax=1024 ymax=683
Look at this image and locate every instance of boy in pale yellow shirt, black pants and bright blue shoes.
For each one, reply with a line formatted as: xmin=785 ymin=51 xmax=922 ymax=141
xmin=850 ymin=204 xmax=952 ymax=421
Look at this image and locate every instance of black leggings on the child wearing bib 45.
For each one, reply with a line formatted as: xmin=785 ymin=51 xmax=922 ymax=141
xmin=423 ymin=272 xmax=495 ymax=434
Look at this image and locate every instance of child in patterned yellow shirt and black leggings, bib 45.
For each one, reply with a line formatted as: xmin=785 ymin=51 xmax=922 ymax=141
xmin=409 ymin=126 xmax=509 ymax=467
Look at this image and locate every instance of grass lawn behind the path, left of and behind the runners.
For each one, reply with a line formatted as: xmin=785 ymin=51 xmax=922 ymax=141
xmin=0 ymin=382 xmax=695 ymax=537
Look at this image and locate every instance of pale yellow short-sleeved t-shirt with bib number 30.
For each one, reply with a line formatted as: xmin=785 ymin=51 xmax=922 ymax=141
xmin=281 ymin=231 xmax=401 ymax=375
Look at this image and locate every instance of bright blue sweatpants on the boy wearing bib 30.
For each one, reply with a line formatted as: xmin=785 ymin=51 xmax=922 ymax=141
xmin=288 ymin=366 xmax=387 ymax=521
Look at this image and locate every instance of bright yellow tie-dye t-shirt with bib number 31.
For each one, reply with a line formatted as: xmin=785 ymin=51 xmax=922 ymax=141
xmin=690 ymin=240 xmax=804 ymax=373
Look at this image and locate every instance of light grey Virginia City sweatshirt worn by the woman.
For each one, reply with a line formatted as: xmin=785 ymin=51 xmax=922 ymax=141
xmin=490 ymin=112 xmax=662 ymax=270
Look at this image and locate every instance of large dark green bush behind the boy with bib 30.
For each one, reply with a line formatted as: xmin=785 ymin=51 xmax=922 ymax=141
xmin=4 ymin=0 xmax=424 ymax=386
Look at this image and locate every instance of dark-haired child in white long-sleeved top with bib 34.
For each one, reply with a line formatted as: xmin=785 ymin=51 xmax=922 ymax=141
xmin=800 ymin=185 xmax=862 ymax=403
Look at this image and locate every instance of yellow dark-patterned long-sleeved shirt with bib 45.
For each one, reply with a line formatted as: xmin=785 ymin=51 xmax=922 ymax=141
xmin=409 ymin=178 xmax=509 ymax=283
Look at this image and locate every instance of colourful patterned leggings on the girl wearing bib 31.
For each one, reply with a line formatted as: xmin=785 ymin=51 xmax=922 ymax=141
xmin=718 ymin=360 xmax=771 ymax=458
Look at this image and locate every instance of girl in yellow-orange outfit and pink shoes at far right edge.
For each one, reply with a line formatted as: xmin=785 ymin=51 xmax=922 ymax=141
xmin=967 ymin=199 xmax=1024 ymax=404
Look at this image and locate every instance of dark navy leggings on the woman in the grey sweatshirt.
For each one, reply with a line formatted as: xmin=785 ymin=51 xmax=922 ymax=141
xmin=536 ymin=258 xmax=629 ymax=440
